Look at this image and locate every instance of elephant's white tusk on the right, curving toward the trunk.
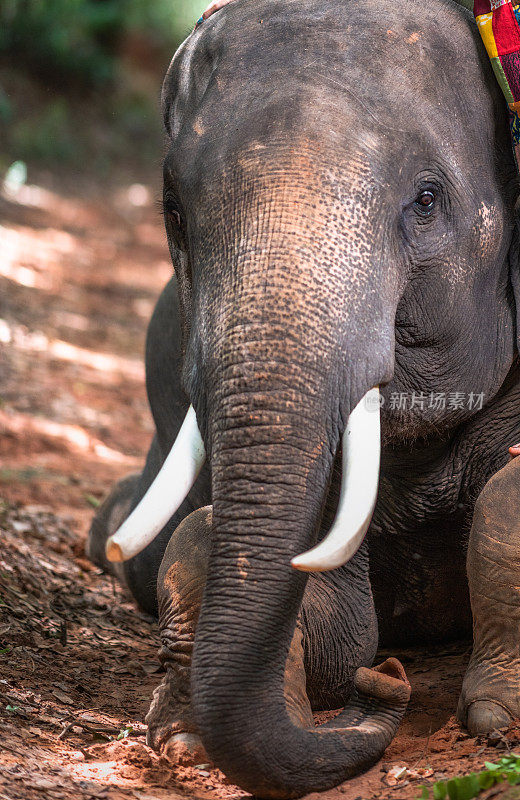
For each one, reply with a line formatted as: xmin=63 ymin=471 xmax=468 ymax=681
xmin=291 ymin=387 xmax=381 ymax=572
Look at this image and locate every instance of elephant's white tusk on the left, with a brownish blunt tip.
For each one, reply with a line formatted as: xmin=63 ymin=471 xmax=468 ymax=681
xmin=106 ymin=406 xmax=206 ymax=562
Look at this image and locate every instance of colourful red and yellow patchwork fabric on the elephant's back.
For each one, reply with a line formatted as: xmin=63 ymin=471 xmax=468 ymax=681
xmin=473 ymin=0 xmax=520 ymax=165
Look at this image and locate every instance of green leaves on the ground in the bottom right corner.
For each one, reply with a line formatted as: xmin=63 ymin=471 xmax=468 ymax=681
xmin=419 ymin=753 xmax=520 ymax=800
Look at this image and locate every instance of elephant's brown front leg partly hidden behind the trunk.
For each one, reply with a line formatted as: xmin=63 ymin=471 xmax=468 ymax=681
xmin=146 ymin=506 xmax=313 ymax=765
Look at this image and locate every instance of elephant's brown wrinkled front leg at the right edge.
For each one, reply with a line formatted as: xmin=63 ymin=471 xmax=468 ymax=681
xmin=457 ymin=459 xmax=520 ymax=735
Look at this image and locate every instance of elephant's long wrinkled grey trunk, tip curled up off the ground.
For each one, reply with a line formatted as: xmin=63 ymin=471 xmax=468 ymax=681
xmin=192 ymin=358 xmax=409 ymax=798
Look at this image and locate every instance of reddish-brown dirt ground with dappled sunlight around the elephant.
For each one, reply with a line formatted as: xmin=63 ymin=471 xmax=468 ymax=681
xmin=0 ymin=170 xmax=520 ymax=800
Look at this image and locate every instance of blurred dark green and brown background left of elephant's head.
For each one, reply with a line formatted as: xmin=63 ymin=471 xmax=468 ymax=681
xmin=0 ymin=0 xmax=206 ymax=174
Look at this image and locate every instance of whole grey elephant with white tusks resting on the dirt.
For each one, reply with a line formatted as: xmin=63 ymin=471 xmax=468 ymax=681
xmin=88 ymin=0 xmax=520 ymax=798
